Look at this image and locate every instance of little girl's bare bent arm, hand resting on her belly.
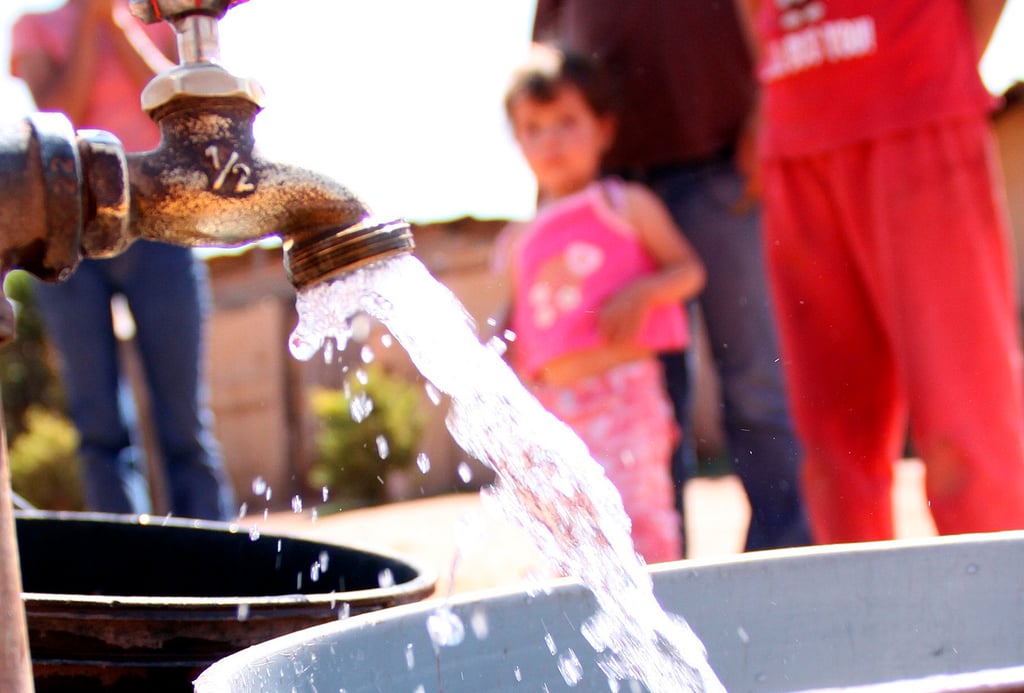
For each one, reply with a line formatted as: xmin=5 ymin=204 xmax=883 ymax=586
xmin=600 ymin=184 xmax=706 ymax=344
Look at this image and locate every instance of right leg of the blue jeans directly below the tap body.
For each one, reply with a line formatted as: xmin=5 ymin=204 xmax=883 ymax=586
xmin=116 ymin=242 xmax=234 ymax=520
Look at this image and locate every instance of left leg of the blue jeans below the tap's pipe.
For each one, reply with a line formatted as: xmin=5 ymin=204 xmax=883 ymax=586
xmin=35 ymin=260 xmax=150 ymax=513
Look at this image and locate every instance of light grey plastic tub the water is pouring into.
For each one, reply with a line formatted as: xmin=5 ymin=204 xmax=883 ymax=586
xmin=196 ymin=532 xmax=1024 ymax=693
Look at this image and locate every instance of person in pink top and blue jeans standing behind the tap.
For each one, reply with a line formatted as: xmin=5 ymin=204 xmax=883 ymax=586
xmin=11 ymin=0 xmax=234 ymax=520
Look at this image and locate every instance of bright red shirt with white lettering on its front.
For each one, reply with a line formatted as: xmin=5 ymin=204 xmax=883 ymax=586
xmin=757 ymin=0 xmax=993 ymax=157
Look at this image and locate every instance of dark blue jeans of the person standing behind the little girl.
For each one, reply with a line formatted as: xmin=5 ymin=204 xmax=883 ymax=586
xmin=631 ymin=154 xmax=811 ymax=551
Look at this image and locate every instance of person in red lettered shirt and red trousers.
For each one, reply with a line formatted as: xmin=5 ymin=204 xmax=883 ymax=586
xmin=750 ymin=0 xmax=1024 ymax=543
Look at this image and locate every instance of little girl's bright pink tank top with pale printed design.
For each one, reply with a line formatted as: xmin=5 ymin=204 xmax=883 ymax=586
xmin=510 ymin=180 xmax=689 ymax=377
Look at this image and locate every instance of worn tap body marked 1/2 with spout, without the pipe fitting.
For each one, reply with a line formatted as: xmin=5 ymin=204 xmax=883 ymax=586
xmin=128 ymin=0 xmax=413 ymax=287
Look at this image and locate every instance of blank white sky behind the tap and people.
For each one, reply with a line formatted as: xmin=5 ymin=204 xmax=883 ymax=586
xmin=0 ymin=0 xmax=1024 ymax=221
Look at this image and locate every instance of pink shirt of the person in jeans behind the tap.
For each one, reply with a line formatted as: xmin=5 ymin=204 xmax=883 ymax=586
xmin=10 ymin=3 xmax=169 ymax=151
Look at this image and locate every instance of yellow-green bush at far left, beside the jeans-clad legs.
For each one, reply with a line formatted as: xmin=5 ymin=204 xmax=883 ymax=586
xmin=9 ymin=405 xmax=85 ymax=510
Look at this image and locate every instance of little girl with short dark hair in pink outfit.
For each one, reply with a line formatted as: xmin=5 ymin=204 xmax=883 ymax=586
xmin=496 ymin=46 xmax=705 ymax=562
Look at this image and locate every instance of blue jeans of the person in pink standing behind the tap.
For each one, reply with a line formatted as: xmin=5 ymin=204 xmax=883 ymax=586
xmin=36 ymin=241 xmax=234 ymax=520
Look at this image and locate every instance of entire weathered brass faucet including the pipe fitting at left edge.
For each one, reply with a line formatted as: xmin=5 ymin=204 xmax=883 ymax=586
xmin=0 ymin=0 xmax=414 ymax=343
